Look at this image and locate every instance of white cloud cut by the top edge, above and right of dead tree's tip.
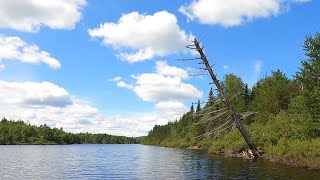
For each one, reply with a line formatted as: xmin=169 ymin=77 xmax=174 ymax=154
xmin=179 ymin=0 xmax=309 ymax=27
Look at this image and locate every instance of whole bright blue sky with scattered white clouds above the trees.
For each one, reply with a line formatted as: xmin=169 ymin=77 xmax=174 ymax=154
xmin=0 ymin=0 xmax=320 ymax=136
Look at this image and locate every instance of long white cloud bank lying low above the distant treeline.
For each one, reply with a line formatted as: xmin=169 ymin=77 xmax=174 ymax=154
xmin=0 ymin=81 xmax=190 ymax=136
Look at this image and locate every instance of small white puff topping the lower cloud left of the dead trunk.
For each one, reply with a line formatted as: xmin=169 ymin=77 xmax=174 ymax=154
xmin=155 ymin=61 xmax=189 ymax=78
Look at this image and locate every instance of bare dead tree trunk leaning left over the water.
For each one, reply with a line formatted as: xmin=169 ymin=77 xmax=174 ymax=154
xmin=187 ymin=38 xmax=260 ymax=158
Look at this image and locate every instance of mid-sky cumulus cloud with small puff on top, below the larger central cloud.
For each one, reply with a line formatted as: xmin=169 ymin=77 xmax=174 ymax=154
xmin=117 ymin=61 xmax=202 ymax=102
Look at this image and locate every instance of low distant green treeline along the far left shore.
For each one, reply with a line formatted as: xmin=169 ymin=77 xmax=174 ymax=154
xmin=0 ymin=118 xmax=137 ymax=145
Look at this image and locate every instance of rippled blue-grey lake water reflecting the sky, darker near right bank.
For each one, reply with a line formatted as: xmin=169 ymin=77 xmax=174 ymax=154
xmin=0 ymin=145 xmax=320 ymax=180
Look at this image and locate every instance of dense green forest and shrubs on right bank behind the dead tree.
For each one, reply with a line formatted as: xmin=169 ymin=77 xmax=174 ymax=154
xmin=142 ymin=33 xmax=320 ymax=168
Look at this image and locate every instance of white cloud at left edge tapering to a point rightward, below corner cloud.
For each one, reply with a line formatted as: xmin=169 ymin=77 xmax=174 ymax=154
xmin=0 ymin=34 xmax=61 ymax=69
